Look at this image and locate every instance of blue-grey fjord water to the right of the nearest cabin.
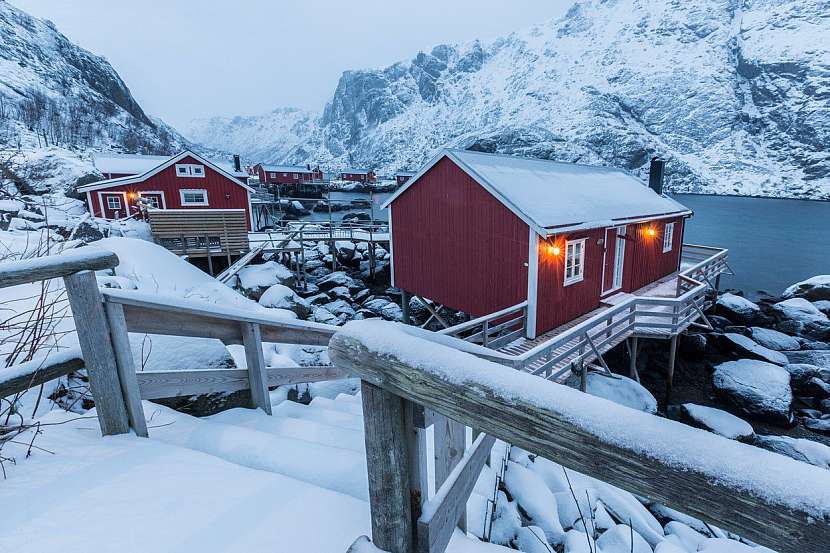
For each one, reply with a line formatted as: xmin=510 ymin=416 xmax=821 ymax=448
xmin=674 ymin=194 xmax=830 ymax=297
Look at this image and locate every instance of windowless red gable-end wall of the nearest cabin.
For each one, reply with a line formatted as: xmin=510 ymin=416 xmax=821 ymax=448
xmin=391 ymin=158 xmax=529 ymax=317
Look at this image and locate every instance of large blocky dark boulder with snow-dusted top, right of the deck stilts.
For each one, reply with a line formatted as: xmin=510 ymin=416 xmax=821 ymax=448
xmin=712 ymin=359 xmax=793 ymax=425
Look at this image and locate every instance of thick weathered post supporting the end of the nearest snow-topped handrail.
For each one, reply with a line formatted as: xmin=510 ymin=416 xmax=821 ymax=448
xmin=360 ymin=382 xmax=415 ymax=553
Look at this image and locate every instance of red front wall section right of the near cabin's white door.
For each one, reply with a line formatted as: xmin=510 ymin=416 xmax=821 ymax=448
xmin=623 ymin=217 xmax=685 ymax=292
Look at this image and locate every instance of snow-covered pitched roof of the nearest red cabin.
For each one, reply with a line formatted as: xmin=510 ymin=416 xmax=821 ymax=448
xmin=384 ymin=149 xmax=691 ymax=235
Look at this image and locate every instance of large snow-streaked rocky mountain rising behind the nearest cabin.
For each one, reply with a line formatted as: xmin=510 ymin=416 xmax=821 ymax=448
xmin=194 ymin=0 xmax=830 ymax=198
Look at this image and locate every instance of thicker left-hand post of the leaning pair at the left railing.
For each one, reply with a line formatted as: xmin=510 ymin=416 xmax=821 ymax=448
xmin=63 ymin=271 xmax=130 ymax=436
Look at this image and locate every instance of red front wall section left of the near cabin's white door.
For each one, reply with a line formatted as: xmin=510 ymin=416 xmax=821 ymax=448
xmin=536 ymin=228 xmax=605 ymax=334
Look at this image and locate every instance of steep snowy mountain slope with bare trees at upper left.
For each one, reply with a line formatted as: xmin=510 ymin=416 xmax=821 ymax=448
xmin=0 ymin=0 xmax=187 ymax=190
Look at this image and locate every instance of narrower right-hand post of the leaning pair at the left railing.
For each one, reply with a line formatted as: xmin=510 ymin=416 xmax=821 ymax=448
xmin=104 ymin=302 xmax=148 ymax=438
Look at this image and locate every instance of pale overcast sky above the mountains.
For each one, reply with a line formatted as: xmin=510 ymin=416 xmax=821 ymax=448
xmin=11 ymin=0 xmax=573 ymax=128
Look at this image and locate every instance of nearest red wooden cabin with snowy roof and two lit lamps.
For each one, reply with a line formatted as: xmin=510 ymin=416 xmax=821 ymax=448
xmin=384 ymin=150 xmax=692 ymax=338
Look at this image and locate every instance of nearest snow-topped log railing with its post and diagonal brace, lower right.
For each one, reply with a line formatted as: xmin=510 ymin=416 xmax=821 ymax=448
xmin=329 ymin=321 xmax=830 ymax=553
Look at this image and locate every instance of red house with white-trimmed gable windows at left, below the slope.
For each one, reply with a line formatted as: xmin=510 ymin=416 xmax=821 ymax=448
xmin=77 ymin=151 xmax=252 ymax=230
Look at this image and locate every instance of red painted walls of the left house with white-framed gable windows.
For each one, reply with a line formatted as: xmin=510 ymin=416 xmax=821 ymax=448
xmin=88 ymin=153 xmax=251 ymax=227
